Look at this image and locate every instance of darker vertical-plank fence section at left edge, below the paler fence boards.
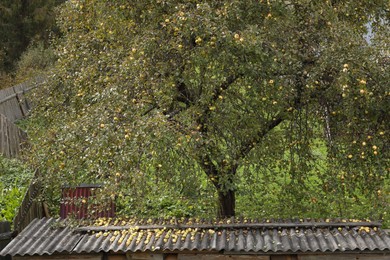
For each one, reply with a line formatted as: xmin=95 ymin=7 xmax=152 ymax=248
xmin=0 ymin=114 xmax=27 ymax=158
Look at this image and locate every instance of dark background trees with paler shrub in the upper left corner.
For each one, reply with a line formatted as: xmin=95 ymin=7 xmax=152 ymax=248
xmin=0 ymin=0 xmax=64 ymax=88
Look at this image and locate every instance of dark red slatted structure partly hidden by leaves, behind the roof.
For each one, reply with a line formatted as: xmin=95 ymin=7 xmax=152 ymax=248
xmin=60 ymin=184 xmax=115 ymax=219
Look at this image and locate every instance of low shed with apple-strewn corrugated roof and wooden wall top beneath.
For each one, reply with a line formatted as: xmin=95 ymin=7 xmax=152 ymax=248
xmin=0 ymin=218 xmax=390 ymax=260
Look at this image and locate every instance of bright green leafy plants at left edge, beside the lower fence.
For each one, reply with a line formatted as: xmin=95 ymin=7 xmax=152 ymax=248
xmin=0 ymin=156 xmax=33 ymax=221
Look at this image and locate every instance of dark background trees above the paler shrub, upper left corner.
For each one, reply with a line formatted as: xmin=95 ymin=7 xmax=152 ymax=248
xmin=0 ymin=0 xmax=64 ymax=88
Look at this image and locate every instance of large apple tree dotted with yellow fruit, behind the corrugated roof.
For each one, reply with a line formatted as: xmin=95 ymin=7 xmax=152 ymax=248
xmin=28 ymin=0 xmax=390 ymax=220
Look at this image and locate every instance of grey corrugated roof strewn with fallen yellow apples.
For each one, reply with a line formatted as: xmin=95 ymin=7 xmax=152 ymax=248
xmin=0 ymin=218 xmax=390 ymax=256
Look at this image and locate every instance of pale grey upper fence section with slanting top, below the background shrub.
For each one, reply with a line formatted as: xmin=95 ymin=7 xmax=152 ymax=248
xmin=0 ymin=77 xmax=45 ymax=122
